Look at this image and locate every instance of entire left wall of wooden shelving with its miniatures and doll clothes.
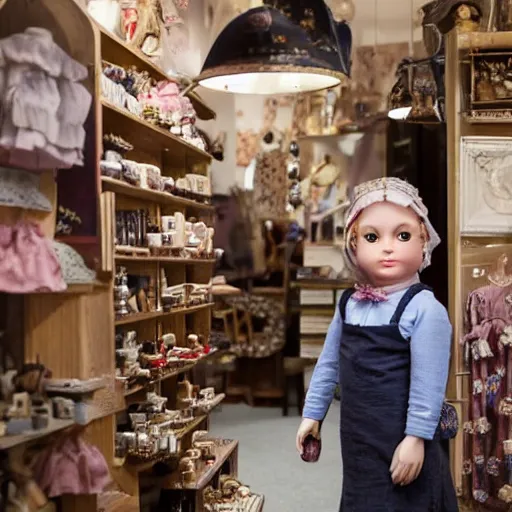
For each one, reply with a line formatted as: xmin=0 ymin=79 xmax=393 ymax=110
xmin=0 ymin=0 xmax=263 ymax=512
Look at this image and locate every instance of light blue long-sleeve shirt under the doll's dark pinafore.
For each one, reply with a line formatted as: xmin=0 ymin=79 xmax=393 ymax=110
xmin=303 ymin=290 xmax=452 ymax=439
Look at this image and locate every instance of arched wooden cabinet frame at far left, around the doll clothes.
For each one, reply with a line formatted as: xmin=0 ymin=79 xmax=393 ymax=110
xmin=0 ymin=0 xmax=120 ymax=512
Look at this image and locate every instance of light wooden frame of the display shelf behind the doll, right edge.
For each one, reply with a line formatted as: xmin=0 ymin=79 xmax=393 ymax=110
xmin=445 ymin=29 xmax=512 ymax=504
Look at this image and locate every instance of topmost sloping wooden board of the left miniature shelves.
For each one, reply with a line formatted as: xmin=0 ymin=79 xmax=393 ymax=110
xmin=96 ymin=23 xmax=215 ymax=121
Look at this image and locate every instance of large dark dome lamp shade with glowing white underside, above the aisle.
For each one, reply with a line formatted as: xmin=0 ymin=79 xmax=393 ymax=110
xmin=196 ymin=4 xmax=352 ymax=94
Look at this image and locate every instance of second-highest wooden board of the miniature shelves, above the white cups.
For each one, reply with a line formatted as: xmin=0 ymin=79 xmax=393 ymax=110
xmin=101 ymin=99 xmax=212 ymax=164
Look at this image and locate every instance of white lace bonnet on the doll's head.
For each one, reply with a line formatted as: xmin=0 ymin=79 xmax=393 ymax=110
xmin=344 ymin=178 xmax=441 ymax=272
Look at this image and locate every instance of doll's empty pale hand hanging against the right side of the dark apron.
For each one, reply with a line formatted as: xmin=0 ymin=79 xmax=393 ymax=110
xmin=389 ymin=436 xmax=425 ymax=485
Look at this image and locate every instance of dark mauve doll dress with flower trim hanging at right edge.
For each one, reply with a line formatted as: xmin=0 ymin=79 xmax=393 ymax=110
xmin=461 ymin=285 xmax=512 ymax=508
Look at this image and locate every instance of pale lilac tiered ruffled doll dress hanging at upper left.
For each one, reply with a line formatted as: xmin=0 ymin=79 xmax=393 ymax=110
xmin=0 ymin=27 xmax=92 ymax=170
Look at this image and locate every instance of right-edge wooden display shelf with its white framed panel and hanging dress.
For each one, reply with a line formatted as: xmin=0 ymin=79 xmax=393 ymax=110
xmin=446 ymin=29 xmax=512 ymax=510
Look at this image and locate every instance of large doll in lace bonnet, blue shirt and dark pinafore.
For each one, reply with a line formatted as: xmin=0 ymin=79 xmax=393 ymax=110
xmin=296 ymin=178 xmax=458 ymax=512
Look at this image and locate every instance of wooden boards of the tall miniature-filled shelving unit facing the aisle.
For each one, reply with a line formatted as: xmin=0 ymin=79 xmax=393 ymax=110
xmin=92 ymin=18 xmax=260 ymax=512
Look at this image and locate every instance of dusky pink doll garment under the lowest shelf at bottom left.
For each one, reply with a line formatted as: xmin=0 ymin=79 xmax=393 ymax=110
xmin=34 ymin=437 xmax=110 ymax=498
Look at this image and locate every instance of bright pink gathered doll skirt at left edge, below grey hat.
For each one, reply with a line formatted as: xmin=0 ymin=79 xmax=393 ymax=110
xmin=0 ymin=222 xmax=66 ymax=293
